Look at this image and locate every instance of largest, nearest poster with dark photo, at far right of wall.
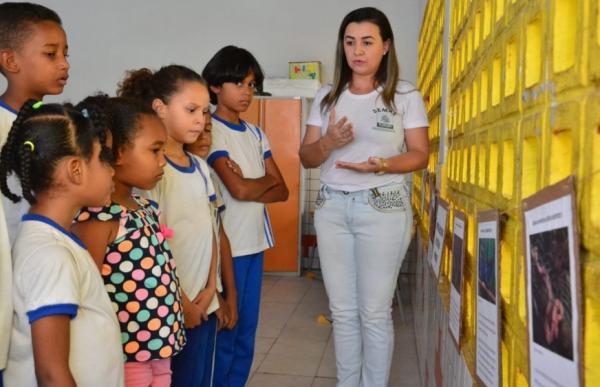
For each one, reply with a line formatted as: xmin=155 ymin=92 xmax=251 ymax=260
xmin=523 ymin=177 xmax=582 ymax=387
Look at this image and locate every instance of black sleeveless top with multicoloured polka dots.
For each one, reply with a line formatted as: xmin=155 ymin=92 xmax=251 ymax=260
xmin=75 ymin=196 xmax=185 ymax=362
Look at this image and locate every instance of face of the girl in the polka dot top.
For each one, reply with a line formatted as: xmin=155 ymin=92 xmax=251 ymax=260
xmin=115 ymin=114 xmax=167 ymax=190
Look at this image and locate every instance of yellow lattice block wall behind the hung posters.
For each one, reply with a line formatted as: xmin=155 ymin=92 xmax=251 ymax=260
xmin=413 ymin=0 xmax=600 ymax=386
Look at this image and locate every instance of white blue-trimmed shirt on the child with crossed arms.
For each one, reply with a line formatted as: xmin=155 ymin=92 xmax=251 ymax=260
xmin=207 ymin=115 xmax=275 ymax=257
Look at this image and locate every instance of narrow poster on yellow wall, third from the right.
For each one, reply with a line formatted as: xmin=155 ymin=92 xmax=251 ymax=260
xmin=448 ymin=210 xmax=467 ymax=347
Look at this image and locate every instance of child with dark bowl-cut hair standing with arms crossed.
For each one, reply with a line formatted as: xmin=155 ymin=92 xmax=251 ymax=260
xmin=202 ymin=46 xmax=288 ymax=387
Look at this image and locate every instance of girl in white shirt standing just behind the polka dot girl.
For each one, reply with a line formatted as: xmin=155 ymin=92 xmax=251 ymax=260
xmin=117 ymin=64 xmax=222 ymax=387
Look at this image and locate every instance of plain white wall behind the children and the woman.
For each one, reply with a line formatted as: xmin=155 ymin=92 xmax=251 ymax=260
xmin=0 ymin=0 xmax=426 ymax=102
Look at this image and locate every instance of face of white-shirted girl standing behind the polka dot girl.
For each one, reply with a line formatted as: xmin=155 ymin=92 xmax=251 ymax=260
xmin=157 ymin=82 xmax=209 ymax=144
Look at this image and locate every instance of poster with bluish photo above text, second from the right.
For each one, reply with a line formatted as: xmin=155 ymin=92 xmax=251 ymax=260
xmin=475 ymin=210 xmax=502 ymax=387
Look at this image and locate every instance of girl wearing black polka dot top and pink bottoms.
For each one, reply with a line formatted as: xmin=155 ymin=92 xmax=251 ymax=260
xmin=73 ymin=95 xmax=186 ymax=387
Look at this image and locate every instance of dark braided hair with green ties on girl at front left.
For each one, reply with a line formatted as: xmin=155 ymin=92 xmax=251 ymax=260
xmin=0 ymin=100 xmax=110 ymax=204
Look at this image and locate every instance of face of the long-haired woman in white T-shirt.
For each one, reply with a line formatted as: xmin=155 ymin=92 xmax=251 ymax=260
xmin=344 ymin=22 xmax=389 ymax=76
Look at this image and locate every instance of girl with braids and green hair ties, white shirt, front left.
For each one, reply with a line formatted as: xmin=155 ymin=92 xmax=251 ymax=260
xmin=0 ymin=100 xmax=123 ymax=386
